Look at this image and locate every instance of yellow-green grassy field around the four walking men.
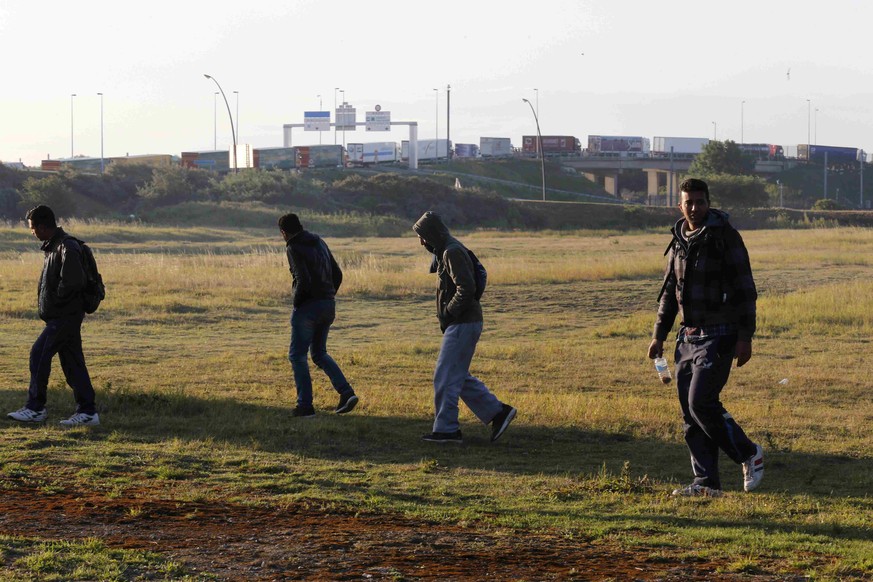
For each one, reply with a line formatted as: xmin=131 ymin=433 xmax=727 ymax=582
xmin=0 ymin=223 xmax=873 ymax=579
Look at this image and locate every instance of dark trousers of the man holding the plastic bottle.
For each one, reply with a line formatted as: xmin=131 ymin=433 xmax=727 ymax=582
xmin=675 ymin=335 xmax=756 ymax=489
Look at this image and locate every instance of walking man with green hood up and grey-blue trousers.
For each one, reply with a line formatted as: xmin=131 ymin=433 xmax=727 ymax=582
xmin=412 ymin=212 xmax=516 ymax=443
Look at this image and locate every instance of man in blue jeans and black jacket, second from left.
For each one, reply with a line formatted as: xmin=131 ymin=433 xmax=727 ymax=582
xmin=279 ymin=214 xmax=358 ymax=418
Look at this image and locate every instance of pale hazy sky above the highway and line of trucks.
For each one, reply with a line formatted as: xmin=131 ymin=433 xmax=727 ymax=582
xmin=0 ymin=0 xmax=873 ymax=165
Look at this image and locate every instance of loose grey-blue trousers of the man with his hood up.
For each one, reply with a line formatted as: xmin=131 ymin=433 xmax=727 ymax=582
xmin=433 ymin=321 xmax=503 ymax=432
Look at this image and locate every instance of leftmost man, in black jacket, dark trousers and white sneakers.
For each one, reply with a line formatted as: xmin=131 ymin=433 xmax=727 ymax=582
xmin=7 ymin=205 xmax=100 ymax=426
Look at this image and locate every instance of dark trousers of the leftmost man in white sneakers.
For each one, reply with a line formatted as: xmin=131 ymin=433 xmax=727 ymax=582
xmin=27 ymin=313 xmax=96 ymax=414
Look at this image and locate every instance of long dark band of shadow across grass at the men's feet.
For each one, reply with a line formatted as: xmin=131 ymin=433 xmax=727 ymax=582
xmin=0 ymin=387 xmax=873 ymax=497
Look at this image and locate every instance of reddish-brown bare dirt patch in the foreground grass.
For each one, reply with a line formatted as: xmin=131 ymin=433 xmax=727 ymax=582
xmin=0 ymin=480 xmax=784 ymax=581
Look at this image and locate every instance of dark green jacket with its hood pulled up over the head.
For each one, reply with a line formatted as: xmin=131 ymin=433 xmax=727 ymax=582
xmin=412 ymin=212 xmax=482 ymax=331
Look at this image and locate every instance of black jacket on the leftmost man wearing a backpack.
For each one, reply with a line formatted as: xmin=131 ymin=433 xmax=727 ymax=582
xmin=37 ymin=227 xmax=85 ymax=321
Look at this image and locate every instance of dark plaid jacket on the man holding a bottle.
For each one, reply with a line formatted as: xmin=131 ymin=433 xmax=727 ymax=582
xmin=653 ymin=209 xmax=758 ymax=341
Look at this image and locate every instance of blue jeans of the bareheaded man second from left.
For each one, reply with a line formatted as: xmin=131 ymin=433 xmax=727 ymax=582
xmin=288 ymin=299 xmax=354 ymax=407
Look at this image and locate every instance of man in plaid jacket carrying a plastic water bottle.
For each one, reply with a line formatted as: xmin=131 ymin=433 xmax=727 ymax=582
xmin=648 ymin=178 xmax=764 ymax=497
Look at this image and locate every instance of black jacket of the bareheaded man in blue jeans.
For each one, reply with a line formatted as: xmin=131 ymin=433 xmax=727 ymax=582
xmin=285 ymin=230 xmax=343 ymax=307
